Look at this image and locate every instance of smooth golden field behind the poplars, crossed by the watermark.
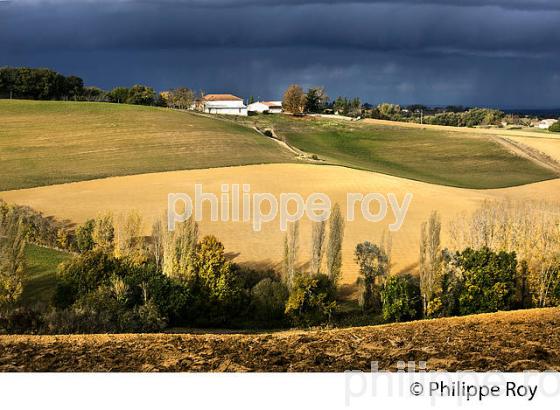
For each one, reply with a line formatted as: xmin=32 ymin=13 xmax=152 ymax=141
xmin=0 ymin=164 xmax=560 ymax=284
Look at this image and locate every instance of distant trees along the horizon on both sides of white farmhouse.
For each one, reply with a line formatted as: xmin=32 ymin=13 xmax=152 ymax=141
xmin=4 ymin=67 xmax=560 ymax=131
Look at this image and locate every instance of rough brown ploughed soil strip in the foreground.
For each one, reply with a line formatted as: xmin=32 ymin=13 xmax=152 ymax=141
xmin=0 ymin=308 xmax=560 ymax=372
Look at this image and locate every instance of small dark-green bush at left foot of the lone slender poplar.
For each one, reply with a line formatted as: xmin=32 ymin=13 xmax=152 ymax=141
xmin=381 ymin=275 xmax=422 ymax=322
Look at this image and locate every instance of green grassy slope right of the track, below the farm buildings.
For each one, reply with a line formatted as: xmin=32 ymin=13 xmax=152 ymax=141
xmin=243 ymin=116 xmax=558 ymax=189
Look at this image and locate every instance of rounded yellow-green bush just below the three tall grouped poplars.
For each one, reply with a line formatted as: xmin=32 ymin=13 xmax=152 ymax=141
xmin=285 ymin=274 xmax=336 ymax=326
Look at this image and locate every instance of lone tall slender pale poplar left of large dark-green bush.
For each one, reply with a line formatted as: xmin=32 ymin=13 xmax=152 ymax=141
xmin=420 ymin=211 xmax=441 ymax=312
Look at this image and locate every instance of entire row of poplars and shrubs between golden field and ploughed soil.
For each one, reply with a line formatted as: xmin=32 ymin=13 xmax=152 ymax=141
xmin=0 ymin=201 xmax=560 ymax=333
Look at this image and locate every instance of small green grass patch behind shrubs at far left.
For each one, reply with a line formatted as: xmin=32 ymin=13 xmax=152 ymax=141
xmin=21 ymin=244 xmax=71 ymax=306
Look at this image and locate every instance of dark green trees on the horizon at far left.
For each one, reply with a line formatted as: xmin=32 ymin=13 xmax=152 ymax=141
xmin=0 ymin=67 xmax=161 ymax=105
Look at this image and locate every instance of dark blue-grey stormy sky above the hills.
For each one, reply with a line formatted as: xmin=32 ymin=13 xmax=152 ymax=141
xmin=0 ymin=0 xmax=560 ymax=108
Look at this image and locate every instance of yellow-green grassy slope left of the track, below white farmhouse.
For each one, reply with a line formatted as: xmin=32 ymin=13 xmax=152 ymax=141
xmin=0 ymin=100 xmax=293 ymax=191
